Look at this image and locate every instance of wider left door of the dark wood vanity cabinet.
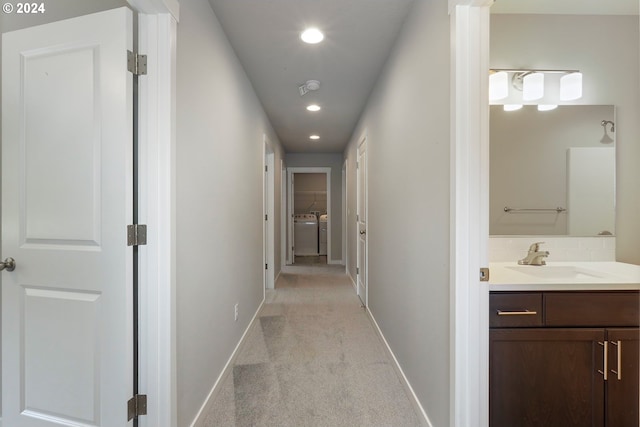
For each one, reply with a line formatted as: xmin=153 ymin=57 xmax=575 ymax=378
xmin=489 ymin=328 xmax=605 ymax=427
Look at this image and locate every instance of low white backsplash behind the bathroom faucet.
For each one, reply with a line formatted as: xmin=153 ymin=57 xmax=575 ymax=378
xmin=489 ymin=236 xmax=616 ymax=262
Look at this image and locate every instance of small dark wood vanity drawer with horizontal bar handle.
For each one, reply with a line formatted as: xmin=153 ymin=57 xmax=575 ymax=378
xmin=489 ymin=292 xmax=542 ymax=328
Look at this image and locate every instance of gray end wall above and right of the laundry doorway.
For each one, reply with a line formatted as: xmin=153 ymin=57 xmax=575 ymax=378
xmin=285 ymin=153 xmax=344 ymax=262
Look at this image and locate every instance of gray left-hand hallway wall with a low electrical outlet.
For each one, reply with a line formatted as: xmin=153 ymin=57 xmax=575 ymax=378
xmin=176 ymin=0 xmax=282 ymax=426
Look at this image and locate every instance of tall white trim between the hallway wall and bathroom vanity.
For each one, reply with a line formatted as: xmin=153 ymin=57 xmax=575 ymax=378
xmin=449 ymin=0 xmax=492 ymax=427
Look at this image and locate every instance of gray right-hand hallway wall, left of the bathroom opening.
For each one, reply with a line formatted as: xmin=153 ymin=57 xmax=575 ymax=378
xmin=345 ymin=0 xmax=450 ymax=426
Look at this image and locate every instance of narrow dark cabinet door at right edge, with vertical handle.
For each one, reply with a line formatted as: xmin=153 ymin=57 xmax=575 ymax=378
xmin=606 ymin=329 xmax=640 ymax=427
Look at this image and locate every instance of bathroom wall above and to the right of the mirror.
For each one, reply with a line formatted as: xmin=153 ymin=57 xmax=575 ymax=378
xmin=490 ymin=14 xmax=640 ymax=264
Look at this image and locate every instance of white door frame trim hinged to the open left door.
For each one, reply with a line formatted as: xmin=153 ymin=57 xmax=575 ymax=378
xmin=129 ymin=0 xmax=178 ymax=427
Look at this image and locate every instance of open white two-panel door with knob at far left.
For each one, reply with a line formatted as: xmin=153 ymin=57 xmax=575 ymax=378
xmin=2 ymin=8 xmax=133 ymax=427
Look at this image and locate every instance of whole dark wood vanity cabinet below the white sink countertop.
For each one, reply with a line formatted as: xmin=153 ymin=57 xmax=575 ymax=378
xmin=489 ymin=291 xmax=640 ymax=427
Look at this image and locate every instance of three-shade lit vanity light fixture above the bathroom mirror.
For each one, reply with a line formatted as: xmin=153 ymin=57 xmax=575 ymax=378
xmin=489 ymin=68 xmax=582 ymax=103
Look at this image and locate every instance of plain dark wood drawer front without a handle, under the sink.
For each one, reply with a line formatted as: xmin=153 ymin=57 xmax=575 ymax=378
xmin=544 ymin=291 xmax=640 ymax=327
